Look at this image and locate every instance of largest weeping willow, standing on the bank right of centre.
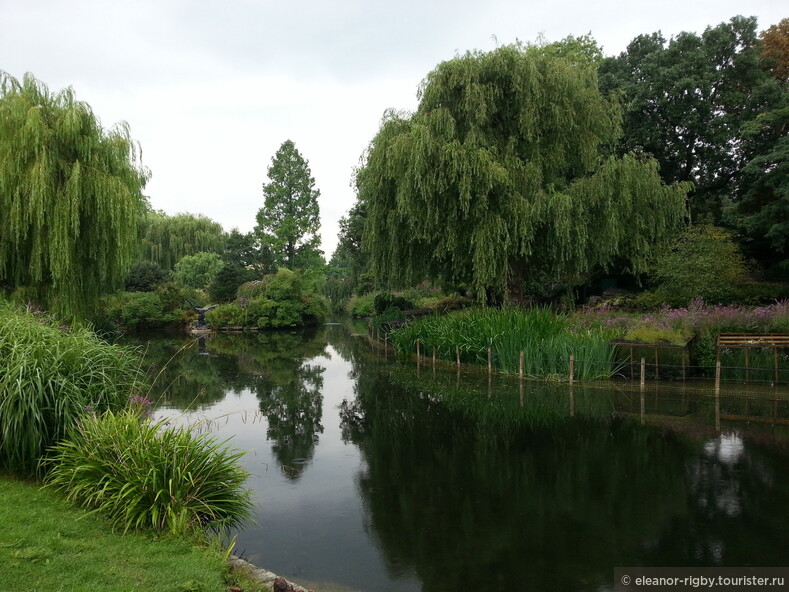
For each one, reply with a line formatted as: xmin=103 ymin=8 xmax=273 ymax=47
xmin=356 ymin=39 xmax=688 ymax=299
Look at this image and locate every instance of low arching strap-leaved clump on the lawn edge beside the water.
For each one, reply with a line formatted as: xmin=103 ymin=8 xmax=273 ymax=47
xmin=47 ymin=409 xmax=253 ymax=535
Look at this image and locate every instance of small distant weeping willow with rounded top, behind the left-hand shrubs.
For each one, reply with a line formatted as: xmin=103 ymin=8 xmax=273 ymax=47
xmin=141 ymin=212 xmax=227 ymax=269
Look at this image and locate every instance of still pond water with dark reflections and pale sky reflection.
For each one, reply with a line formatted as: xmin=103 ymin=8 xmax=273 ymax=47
xmin=137 ymin=325 xmax=789 ymax=592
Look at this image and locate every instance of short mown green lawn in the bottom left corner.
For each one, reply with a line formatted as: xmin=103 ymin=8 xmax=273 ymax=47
xmin=0 ymin=475 xmax=264 ymax=592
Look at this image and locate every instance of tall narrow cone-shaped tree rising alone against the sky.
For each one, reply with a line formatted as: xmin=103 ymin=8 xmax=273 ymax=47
xmin=255 ymin=140 xmax=322 ymax=269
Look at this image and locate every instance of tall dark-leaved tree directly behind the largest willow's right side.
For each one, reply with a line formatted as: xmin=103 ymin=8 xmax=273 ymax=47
xmin=600 ymin=16 xmax=781 ymax=222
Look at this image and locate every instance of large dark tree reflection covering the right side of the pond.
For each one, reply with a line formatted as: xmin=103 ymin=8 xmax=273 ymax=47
xmin=341 ymin=359 xmax=789 ymax=591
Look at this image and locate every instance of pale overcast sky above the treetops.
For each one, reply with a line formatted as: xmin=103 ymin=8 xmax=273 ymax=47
xmin=0 ymin=0 xmax=789 ymax=257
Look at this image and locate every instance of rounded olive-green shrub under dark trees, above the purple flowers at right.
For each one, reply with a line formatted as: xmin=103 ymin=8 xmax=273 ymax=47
xmin=651 ymin=225 xmax=748 ymax=305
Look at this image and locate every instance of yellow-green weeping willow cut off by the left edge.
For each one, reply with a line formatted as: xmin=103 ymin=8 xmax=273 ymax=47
xmin=0 ymin=71 xmax=148 ymax=318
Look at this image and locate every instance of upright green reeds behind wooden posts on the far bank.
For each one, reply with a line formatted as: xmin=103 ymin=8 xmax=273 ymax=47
xmin=390 ymin=308 xmax=616 ymax=380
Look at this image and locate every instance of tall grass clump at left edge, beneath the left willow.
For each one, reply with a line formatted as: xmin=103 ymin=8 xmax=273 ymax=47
xmin=0 ymin=302 xmax=142 ymax=475
